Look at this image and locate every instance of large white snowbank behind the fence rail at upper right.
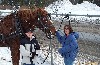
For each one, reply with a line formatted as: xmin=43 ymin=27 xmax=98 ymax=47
xmin=45 ymin=0 xmax=100 ymax=19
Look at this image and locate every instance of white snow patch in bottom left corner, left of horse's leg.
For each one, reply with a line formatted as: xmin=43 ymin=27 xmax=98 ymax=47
xmin=0 ymin=47 xmax=12 ymax=65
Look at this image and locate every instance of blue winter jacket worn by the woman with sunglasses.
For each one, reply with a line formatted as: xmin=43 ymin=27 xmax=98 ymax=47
xmin=56 ymin=30 xmax=79 ymax=61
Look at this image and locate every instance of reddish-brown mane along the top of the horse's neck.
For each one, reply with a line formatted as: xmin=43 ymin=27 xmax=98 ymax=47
xmin=18 ymin=8 xmax=48 ymax=19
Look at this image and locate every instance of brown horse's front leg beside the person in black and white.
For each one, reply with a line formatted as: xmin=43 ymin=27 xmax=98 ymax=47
xmin=11 ymin=37 xmax=20 ymax=65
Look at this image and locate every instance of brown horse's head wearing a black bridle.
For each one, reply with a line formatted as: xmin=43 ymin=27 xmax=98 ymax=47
xmin=33 ymin=8 xmax=55 ymax=37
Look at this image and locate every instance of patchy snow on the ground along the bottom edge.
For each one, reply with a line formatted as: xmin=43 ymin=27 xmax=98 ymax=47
xmin=0 ymin=47 xmax=97 ymax=65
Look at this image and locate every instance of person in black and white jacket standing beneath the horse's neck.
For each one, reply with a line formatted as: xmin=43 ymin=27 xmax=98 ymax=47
xmin=20 ymin=29 xmax=40 ymax=65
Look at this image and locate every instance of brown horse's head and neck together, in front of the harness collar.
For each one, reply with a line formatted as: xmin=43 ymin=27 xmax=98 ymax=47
xmin=19 ymin=8 xmax=55 ymax=37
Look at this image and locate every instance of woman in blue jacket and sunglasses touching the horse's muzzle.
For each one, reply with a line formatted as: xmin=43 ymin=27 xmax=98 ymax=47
xmin=56 ymin=25 xmax=79 ymax=65
